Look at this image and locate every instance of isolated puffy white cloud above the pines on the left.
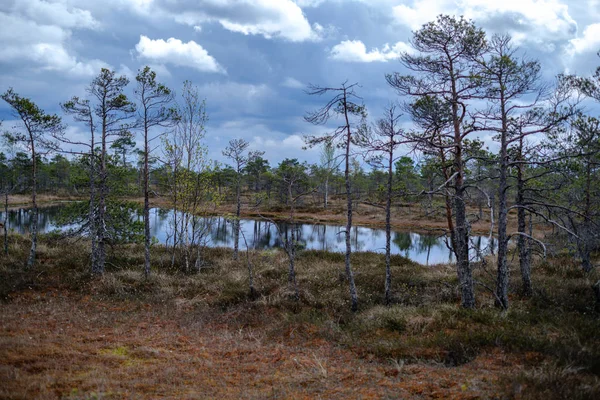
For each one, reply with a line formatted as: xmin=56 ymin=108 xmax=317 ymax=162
xmin=135 ymin=35 xmax=225 ymax=73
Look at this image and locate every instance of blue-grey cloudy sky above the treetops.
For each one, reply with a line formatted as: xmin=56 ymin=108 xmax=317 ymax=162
xmin=0 ymin=0 xmax=600 ymax=166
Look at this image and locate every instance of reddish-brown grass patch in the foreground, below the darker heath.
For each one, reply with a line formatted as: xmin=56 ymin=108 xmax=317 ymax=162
xmin=0 ymin=291 xmax=522 ymax=399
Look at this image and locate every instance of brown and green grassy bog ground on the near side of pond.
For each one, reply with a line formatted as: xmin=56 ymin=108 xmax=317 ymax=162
xmin=0 ymin=237 xmax=600 ymax=399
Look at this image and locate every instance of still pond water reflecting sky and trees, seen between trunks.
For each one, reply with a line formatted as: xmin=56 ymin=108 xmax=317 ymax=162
xmin=0 ymin=204 xmax=489 ymax=265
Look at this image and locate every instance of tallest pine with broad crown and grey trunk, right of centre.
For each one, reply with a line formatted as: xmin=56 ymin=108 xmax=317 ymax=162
xmin=386 ymin=15 xmax=487 ymax=308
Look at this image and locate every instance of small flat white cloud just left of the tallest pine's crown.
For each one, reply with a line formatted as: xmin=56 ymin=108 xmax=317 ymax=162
xmin=330 ymin=40 xmax=413 ymax=63
